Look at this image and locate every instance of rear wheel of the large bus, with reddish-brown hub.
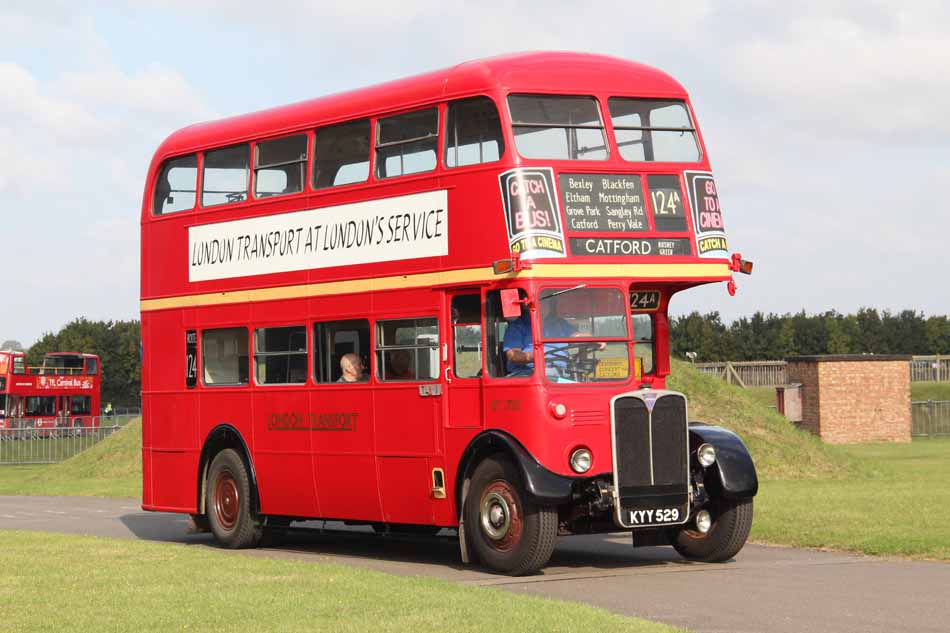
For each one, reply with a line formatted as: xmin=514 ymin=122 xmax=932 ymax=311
xmin=205 ymin=448 xmax=263 ymax=549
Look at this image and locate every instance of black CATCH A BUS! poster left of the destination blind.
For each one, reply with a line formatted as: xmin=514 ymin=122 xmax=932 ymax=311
xmin=498 ymin=167 xmax=565 ymax=259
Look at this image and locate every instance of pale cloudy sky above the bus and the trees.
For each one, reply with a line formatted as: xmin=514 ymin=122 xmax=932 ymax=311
xmin=0 ymin=0 xmax=950 ymax=346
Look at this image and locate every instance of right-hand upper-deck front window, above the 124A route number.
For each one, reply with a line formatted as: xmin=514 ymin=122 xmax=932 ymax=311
xmin=607 ymin=97 xmax=700 ymax=163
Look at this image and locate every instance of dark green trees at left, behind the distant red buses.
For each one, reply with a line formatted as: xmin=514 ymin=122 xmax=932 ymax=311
xmin=26 ymin=318 xmax=142 ymax=407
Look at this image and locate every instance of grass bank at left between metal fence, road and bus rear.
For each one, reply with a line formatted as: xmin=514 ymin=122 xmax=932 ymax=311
xmin=0 ymin=419 xmax=142 ymax=497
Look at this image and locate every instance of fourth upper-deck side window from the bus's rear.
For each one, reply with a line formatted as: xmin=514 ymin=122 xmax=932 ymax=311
xmin=313 ymin=119 xmax=369 ymax=189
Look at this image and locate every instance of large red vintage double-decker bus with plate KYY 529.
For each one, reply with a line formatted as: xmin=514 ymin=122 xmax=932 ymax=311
xmin=141 ymin=53 xmax=758 ymax=574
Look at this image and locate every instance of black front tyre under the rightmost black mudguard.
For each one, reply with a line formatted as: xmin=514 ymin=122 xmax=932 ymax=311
xmin=672 ymin=499 xmax=752 ymax=563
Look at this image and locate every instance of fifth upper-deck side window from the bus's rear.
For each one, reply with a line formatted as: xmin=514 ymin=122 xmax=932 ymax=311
xmin=376 ymin=108 xmax=439 ymax=178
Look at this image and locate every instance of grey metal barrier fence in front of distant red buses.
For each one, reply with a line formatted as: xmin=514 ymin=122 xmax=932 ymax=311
xmin=0 ymin=413 xmax=138 ymax=466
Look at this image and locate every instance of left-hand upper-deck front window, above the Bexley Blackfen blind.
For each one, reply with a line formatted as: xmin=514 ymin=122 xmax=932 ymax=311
xmin=508 ymin=95 xmax=607 ymax=160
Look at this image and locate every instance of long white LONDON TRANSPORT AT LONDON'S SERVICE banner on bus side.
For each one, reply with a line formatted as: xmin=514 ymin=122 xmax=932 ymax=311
xmin=188 ymin=189 xmax=449 ymax=282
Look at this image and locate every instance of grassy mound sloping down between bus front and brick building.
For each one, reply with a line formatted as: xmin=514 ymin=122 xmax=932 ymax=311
xmin=667 ymin=361 xmax=864 ymax=479
